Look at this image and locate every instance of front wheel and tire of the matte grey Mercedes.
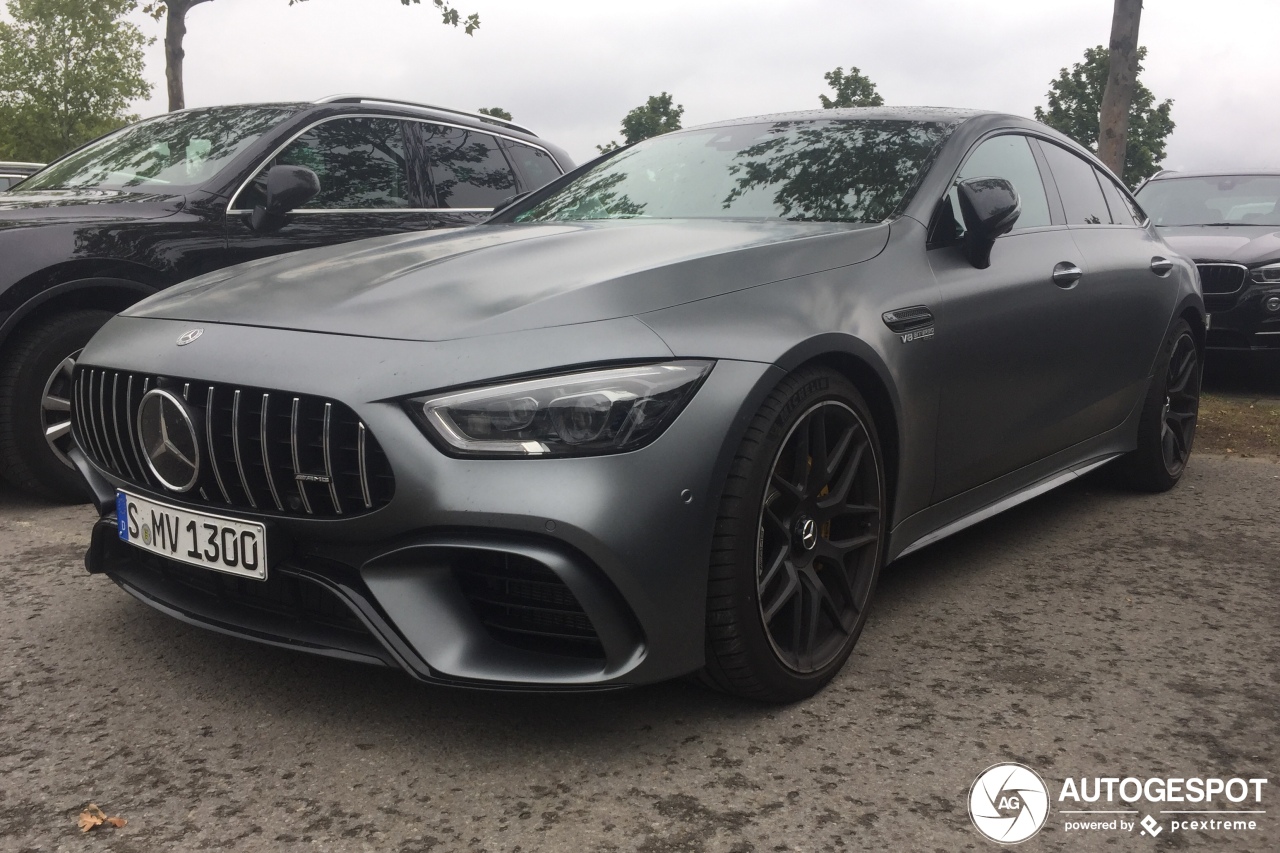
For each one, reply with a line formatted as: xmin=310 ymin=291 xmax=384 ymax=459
xmin=700 ymin=368 xmax=887 ymax=702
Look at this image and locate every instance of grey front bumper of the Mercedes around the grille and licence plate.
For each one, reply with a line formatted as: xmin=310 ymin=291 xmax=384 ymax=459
xmin=77 ymin=320 xmax=777 ymax=689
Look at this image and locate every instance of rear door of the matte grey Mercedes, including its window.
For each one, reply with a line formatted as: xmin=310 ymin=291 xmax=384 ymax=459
xmin=1039 ymin=141 xmax=1176 ymax=435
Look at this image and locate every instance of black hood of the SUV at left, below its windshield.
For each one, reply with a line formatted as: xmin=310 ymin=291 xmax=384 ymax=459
xmin=0 ymin=187 xmax=186 ymax=229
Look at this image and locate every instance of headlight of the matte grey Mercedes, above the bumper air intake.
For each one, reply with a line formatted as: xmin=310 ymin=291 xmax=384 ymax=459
xmin=408 ymin=361 xmax=714 ymax=456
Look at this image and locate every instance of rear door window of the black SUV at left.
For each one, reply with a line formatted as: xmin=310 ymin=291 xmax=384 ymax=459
xmin=413 ymin=122 xmax=516 ymax=209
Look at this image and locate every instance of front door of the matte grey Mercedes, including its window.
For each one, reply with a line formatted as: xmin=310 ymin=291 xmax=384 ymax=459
xmin=928 ymin=133 xmax=1101 ymax=501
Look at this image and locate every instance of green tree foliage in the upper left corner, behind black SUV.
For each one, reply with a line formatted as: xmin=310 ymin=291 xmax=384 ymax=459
xmin=0 ymin=0 xmax=151 ymax=161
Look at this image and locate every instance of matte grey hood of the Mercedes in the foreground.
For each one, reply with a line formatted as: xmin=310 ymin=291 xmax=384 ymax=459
xmin=128 ymin=220 xmax=890 ymax=341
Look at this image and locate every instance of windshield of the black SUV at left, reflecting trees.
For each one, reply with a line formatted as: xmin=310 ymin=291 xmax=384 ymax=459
xmin=22 ymin=106 xmax=294 ymax=192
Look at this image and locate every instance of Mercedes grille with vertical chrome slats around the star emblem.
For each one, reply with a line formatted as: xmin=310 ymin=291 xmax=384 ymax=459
xmin=72 ymin=366 xmax=396 ymax=517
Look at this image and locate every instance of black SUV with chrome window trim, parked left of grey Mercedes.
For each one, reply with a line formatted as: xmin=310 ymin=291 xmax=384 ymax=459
xmin=0 ymin=95 xmax=572 ymax=500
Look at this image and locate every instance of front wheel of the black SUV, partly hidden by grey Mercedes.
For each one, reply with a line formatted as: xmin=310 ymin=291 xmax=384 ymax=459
xmin=0 ymin=310 xmax=111 ymax=503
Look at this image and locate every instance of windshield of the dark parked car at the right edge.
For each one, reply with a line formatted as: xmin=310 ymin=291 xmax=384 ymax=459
xmin=1138 ymin=174 xmax=1280 ymax=225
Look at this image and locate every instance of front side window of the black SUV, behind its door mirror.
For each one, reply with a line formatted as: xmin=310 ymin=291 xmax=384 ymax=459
xmin=236 ymin=118 xmax=411 ymax=210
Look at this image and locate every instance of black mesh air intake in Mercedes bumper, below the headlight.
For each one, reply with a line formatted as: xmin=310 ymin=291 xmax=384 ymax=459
xmin=456 ymin=551 xmax=604 ymax=660
